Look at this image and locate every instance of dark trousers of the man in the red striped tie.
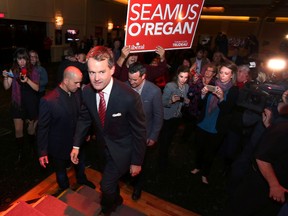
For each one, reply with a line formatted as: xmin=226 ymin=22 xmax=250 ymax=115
xmin=100 ymin=147 xmax=124 ymax=213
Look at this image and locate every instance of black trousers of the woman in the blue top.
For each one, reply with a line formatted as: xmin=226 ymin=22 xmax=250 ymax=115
xmin=195 ymin=127 xmax=223 ymax=177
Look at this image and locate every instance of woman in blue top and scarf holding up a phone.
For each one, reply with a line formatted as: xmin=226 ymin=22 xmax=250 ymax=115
xmin=191 ymin=62 xmax=238 ymax=184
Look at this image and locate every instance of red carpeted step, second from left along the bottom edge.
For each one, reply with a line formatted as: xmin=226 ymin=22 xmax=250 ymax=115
xmin=33 ymin=195 xmax=85 ymax=216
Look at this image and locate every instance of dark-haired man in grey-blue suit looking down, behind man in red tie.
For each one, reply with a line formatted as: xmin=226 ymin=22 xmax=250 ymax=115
xmin=128 ymin=62 xmax=163 ymax=200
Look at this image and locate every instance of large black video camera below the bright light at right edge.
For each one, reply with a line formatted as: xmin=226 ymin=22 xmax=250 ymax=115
xmin=237 ymin=82 xmax=287 ymax=113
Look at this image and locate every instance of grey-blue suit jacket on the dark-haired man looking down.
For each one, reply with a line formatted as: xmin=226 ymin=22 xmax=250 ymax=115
xmin=141 ymin=80 xmax=163 ymax=141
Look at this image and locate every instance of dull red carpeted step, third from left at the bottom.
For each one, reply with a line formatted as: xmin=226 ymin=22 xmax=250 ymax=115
xmin=58 ymin=189 xmax=101 ymax=216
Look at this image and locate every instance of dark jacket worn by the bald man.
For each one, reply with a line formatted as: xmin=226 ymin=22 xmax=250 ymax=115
xmin=37 ymin=87 xmax=81 ymax=160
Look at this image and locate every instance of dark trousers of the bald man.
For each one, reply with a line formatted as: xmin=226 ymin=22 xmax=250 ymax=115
xmin=52 ymin=151 xmax=87 ymax=189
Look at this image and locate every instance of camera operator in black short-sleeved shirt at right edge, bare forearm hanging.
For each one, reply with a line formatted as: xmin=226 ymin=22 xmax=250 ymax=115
xmin=223 ymin=91 xmax=288 ymax=216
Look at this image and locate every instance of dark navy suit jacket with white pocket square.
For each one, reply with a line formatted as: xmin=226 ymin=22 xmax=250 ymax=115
xmin=74 ymin=79 xmax=146 ymax=173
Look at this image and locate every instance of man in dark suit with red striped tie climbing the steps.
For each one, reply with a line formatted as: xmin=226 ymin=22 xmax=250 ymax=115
xmin=71 ymin=46 xmax=146 ymax=215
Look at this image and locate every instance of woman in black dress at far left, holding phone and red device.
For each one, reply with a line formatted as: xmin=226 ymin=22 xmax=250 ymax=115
xmin=2 ymin=48 xmax=39 ymax=162
